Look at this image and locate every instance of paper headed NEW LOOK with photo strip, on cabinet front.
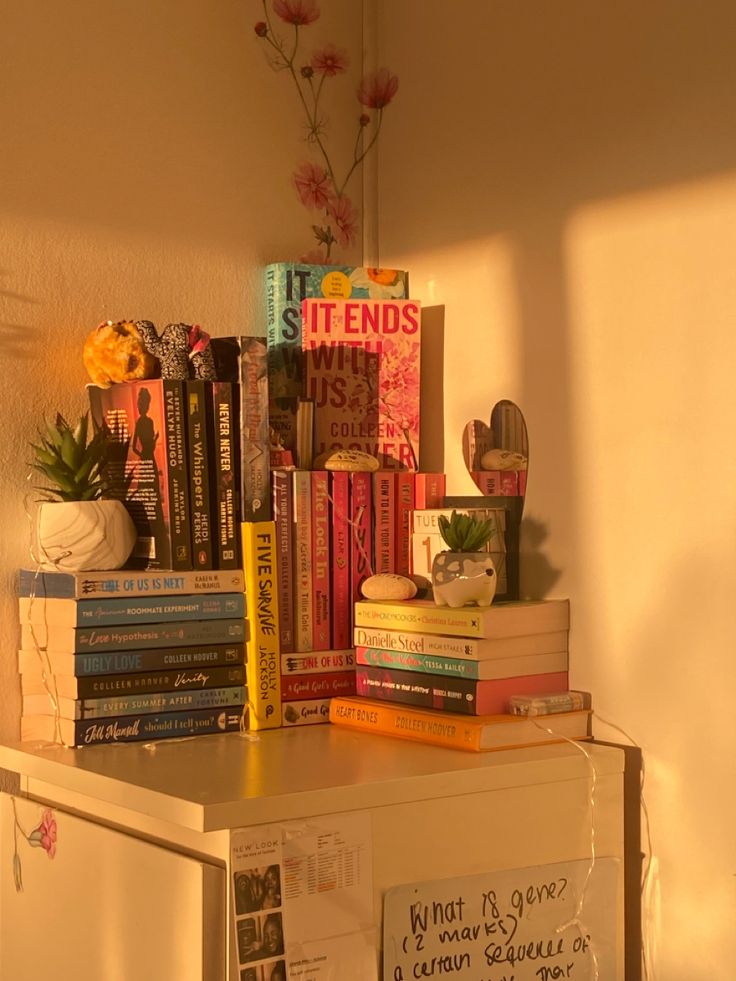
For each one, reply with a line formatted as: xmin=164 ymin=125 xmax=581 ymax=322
xmin=230 ymin=813 xmax=378 ymax=981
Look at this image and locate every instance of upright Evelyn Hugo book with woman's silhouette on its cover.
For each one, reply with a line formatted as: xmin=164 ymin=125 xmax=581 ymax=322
xmin=88 ymin=378 xmax=192 ymax=570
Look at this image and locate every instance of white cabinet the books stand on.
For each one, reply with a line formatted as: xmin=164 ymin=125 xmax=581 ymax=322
xmin=0 ymin=725 xmax=624 ymax=981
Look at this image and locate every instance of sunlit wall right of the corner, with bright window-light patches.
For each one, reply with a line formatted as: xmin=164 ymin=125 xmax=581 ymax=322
xmin=378 ymin=0 xmax=736 ymax=981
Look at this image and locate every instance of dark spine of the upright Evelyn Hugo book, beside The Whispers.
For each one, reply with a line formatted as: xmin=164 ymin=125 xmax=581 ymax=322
xmin=163 ymin=378 xmax=192 ymax=570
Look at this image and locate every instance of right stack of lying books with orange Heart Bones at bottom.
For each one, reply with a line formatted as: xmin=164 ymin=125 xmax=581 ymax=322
xmin=330 ymin=600 xmax=588 ymax=750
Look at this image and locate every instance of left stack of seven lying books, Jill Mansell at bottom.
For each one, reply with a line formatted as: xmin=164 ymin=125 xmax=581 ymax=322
xmin=17 ymin=570 xmax=247 ymax=746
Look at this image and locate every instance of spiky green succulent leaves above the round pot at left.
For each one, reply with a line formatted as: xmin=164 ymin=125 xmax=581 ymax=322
xmin=31 ymin=413 xmax=117 ymax=501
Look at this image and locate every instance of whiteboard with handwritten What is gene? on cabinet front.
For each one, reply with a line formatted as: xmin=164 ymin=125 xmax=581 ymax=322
xmin=383 ymin=858 xmax=622 ymax=981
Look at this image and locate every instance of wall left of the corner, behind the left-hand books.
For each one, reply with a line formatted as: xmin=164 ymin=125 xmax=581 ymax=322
xmin=0 ymin=0 xmax=363 ymax=739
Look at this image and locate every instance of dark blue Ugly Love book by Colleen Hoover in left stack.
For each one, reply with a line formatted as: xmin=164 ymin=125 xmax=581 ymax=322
xmin=18 ymin=643 xmax=245 ymax=678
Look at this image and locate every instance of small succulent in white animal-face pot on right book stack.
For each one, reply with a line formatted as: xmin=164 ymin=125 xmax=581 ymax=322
xmin=432 ymin=511 xmax=498 ymax=607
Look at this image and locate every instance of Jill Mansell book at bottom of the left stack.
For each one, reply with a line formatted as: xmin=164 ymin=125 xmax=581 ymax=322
xmin=20 ymin=705 xmax=243 ymax=746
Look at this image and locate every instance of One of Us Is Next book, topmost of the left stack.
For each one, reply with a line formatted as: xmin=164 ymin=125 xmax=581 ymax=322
xmin=16 ymin=569 xmax=244 ymax=600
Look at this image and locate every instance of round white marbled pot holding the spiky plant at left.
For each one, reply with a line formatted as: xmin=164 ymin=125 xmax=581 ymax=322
xmin=36 ymin=500 xmax=137 ymax=572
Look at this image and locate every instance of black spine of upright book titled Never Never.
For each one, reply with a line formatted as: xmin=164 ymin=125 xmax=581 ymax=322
xmin=207 ymin=381 xmax=239 ymax=569
